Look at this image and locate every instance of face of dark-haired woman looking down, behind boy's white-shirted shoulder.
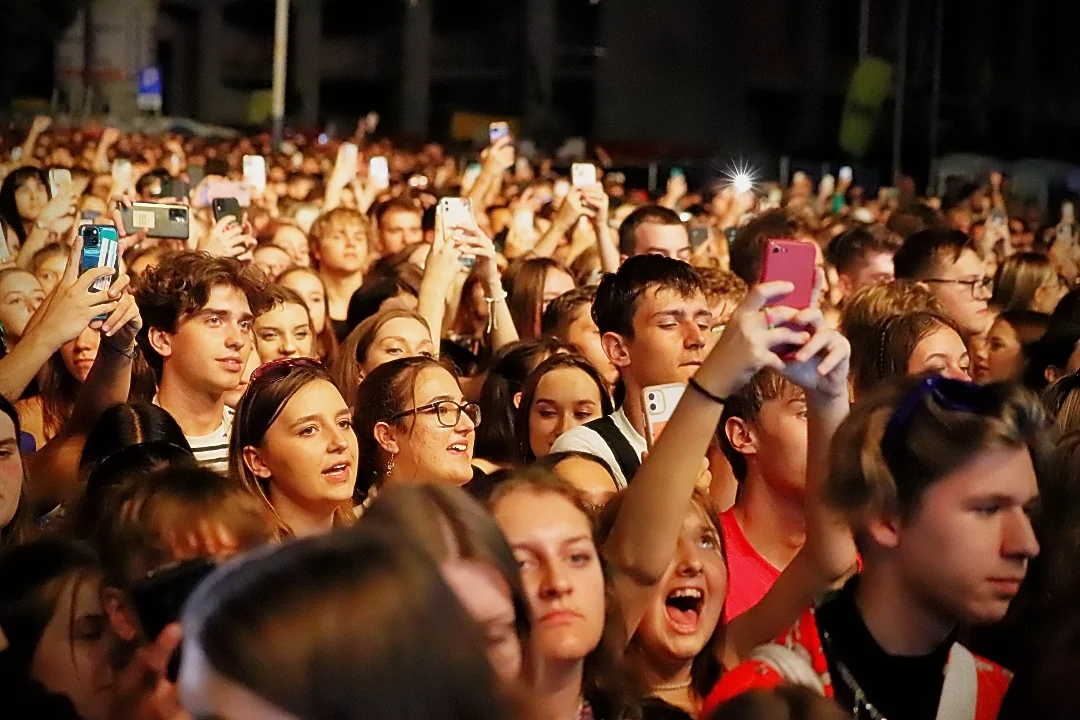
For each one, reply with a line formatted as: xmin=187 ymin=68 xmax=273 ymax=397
xmin=529 ymin=367 xmax=603 ymax=458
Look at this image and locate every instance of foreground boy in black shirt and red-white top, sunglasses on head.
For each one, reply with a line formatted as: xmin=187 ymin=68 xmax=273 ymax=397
xmin=702 ymin=378 xmax=1052 ymax=720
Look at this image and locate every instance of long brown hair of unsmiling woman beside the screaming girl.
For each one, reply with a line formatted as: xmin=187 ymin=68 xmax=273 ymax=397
xmin=487 ymin=466 xmax=640 ymax=720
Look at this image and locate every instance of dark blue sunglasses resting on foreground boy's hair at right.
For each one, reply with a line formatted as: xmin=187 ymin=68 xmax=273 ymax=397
xmin=881 ymin=375 xmax=1005 ymax=473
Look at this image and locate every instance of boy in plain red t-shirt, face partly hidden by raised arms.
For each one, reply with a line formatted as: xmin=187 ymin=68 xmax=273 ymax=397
xmin=717 ymin=369 xmax=807 ymax=622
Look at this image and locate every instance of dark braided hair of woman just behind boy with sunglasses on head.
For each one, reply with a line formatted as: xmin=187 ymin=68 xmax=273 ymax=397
xmin=851 ymin=311 xmax=963 ymax=398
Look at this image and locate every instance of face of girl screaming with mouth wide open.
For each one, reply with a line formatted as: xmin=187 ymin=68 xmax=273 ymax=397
xmin=635 ymin=504 xmax=728 ymax=664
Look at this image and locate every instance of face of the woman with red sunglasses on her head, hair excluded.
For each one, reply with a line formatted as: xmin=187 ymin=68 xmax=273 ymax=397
xmin=244 ymin=380 xmax=357 ymax=513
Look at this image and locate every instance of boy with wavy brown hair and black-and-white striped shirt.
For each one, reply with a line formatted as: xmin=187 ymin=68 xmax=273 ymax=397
xmin=135 ymin=253 xmax=270 ymax=472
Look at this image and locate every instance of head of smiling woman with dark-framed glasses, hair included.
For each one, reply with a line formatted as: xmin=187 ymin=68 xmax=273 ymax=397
xmin=354 ymin=355 xmax=481 ymax=502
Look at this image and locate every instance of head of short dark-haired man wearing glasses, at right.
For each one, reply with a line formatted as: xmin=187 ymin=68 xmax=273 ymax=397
xmin=892 ymin=228 xmax=994 ymax=339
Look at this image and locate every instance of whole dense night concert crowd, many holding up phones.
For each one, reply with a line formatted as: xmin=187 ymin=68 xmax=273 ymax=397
xmin=0 ymin=111 xmax=1080 ymax=720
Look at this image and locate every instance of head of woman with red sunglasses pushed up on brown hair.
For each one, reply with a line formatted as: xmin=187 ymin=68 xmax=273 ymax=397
xmin=229 ymin=357 xmax=359 ymax=535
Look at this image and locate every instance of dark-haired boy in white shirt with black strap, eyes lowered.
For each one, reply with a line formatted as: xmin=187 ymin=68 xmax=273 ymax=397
xmin=552 ymin=254 xmax=712 ymax=488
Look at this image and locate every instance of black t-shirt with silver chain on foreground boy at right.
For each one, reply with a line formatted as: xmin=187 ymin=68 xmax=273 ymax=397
xmin=816 ymin=578 xmax=954 ymax=720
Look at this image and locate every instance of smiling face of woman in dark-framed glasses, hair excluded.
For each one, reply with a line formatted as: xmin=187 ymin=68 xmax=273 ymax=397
xmin=384 ymin=367 xmax=476 ymax=485
